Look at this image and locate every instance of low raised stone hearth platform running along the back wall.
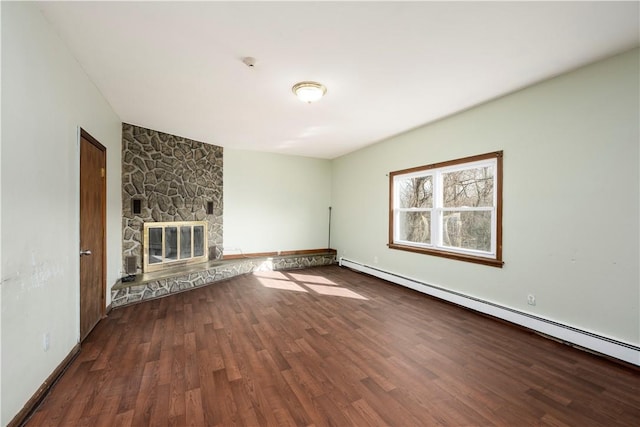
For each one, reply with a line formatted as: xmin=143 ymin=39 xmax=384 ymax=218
xmin=111 ymin=251 xmax=336 ymax=308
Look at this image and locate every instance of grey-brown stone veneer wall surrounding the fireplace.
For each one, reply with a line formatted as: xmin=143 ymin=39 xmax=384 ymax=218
xmin=122 ymin=123 xmax=223 ymax=271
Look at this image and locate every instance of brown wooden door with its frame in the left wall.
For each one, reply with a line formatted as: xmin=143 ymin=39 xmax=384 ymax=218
xmin=80 ymin=130 xmax=107 ymax=341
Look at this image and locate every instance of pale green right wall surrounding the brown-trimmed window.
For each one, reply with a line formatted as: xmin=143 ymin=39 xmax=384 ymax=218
xmin=332 ymin=49 xmax=640 ymax=345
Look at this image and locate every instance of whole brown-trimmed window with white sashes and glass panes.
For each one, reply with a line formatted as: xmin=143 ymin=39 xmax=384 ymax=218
xmin=389 ymin=151 xmax=503 ymax=267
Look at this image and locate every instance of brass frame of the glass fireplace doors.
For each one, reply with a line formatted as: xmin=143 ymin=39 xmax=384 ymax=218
xmin=142 ymin=221 xmax=209 ymax=273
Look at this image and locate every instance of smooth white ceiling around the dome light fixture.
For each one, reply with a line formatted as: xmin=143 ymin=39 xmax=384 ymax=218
xmin=40 ymin=1 xmax=640 ymax=158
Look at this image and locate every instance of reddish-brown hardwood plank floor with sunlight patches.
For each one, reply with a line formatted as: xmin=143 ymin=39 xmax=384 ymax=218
xmin=27 ymin=266 xmax=640 ymax=426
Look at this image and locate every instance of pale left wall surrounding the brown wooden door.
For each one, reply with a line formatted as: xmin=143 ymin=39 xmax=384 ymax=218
xmin=0 ymin=2 xmax=122 ymax=425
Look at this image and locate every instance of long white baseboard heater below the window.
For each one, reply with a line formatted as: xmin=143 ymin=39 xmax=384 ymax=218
xmin=338 ymin=257 xmax=640 ymax=366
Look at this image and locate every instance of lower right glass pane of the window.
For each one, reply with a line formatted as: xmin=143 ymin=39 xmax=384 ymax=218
xmin=442 ymin=211 xmax=491 ymax=252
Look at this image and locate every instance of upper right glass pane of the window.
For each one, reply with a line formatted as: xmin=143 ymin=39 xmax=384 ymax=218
xmin=442 ymin=166 xmax=493 ymax=208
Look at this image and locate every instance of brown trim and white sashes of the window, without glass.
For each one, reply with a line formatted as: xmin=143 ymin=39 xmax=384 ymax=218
xmin=387 ymin=151 xmax=504 ymax=268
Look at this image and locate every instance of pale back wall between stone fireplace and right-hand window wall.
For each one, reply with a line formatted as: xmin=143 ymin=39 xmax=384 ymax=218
xmin=223 ymin=148 xmax=331 ymax=255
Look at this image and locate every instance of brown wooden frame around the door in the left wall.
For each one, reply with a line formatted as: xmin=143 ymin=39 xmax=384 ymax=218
xmin=77 ymin=127 xmax=107 ymax=342
